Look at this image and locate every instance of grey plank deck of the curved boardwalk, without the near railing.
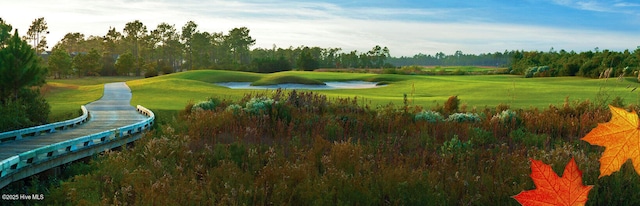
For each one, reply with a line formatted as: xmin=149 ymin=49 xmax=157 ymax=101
xmin=0 ymin=82 xmax=147 ymax=167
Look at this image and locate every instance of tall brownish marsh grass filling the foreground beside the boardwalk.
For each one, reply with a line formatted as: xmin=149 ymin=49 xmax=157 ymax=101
xmin=47 ymin=90 xmax=640 ymax=205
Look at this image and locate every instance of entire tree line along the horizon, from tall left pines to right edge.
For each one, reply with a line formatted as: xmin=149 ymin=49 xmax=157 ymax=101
xmin=13 ymin=18 xmax=640 ymax=78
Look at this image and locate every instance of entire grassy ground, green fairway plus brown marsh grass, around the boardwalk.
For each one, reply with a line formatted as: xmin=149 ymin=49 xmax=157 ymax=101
xmin=36 ymin=70 xmax=640 ymax=205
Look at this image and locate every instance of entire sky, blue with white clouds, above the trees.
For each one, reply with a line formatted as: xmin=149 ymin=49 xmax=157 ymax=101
xmin=0 ymin=0 xmax=640 ymax=57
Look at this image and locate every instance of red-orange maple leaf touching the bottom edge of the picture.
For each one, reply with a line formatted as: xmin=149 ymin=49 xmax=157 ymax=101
xmin=513 ymin=158 xmax=593 ymax=205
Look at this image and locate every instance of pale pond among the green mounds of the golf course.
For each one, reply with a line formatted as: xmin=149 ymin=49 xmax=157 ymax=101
xmin=215 ymin=81 xmax=385 ymax=90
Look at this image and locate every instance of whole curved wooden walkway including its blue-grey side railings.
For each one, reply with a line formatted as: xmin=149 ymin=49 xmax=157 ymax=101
xmin=0 ymin=82 xmax=155 ymax=188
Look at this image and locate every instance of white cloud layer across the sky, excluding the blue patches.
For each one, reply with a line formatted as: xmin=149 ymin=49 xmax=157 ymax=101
xmin=0 ymin=0 xmax=640 ymax=56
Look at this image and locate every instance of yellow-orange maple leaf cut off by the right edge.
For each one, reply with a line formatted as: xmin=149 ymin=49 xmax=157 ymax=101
xmin=582 ymin=105 xmax=640 ymax=177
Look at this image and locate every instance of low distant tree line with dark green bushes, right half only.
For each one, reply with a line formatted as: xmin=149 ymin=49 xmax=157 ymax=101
xmin=388 ymin=47 xmax=640 ymax=78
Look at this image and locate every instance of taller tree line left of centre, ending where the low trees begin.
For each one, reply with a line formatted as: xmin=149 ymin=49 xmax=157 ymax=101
xmin=34 ymin=20 xmax=391 ymax=78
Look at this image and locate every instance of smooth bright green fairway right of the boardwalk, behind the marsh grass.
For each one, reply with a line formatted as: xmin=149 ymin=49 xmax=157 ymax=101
xmin=127 ymin=71 xmax=639 ymax=110
